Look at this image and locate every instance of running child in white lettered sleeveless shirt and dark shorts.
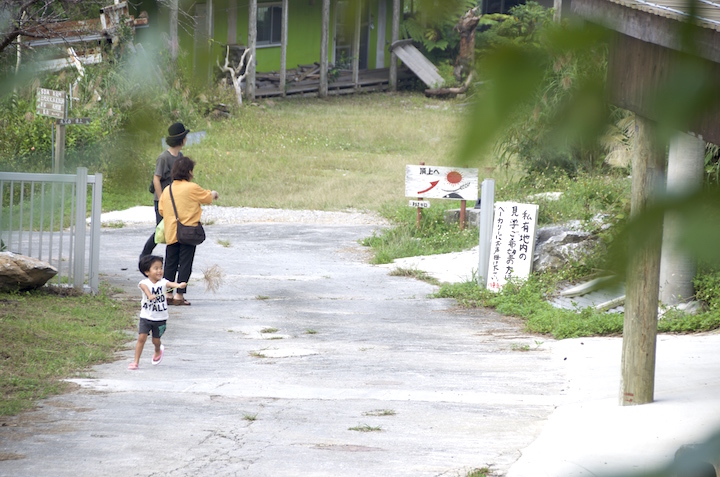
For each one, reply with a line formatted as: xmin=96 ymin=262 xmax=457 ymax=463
xmin=128 ymin=255 xmax=187 ymax=370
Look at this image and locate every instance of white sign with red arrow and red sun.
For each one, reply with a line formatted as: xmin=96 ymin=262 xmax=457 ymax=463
xmin=405 ymin=165 xmax=478 ymax=201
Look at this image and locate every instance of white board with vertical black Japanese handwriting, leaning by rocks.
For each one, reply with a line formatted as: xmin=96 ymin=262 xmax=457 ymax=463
xmin=487 ymin=202 xmax=538 ymax=292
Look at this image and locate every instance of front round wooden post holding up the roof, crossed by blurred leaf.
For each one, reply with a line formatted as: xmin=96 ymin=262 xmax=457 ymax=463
xmin=620 ymin=114 xmax=665 ymax=406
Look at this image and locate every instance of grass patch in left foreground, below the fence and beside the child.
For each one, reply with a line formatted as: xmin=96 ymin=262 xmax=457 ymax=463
xmin=0 ymin=288 xmax=135 ymax=415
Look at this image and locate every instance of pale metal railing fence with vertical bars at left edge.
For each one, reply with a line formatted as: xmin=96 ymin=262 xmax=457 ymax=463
xmin=0 ymin=167 xmax=102 ymax=293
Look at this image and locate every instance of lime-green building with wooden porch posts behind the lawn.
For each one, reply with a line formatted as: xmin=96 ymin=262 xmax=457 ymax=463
xmin=131 ymin=0 xmax=416 ymax=99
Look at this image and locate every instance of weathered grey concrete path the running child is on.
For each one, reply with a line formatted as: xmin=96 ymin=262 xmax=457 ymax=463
xmin=0 ymin=219 xmax=567 ymax=477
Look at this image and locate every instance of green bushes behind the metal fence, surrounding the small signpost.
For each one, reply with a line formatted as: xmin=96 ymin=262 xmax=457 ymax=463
xmin=0 ymin=35 xmax=234 ymax=208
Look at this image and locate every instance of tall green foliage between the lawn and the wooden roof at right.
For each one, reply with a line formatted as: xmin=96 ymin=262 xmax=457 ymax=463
xmin=476 ymin=2 xmax=612 ymax=175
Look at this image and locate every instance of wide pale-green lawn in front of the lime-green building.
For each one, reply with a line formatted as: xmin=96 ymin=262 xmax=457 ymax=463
xmin=103 ymin=93 xmax=464 ymax=210
